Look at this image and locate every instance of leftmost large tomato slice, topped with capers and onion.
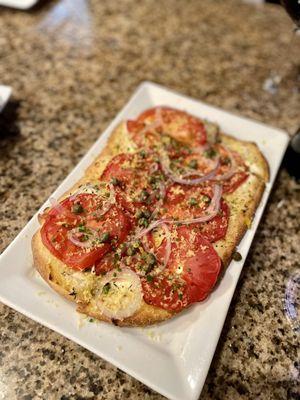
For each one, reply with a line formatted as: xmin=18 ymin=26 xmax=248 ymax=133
xmin=41 ymin=194 xmax=131 ymax=270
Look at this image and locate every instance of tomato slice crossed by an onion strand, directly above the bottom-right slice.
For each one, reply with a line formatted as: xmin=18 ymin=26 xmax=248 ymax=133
xmin=162 ymin=183 xmax=229 ymax=242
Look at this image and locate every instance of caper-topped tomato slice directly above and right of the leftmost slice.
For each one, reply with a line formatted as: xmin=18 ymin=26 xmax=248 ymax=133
xmin=100 ymin=150 xmax=164 ymax=217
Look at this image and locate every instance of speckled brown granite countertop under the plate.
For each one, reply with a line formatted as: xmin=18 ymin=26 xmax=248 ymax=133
xmin=0 ymin=0 xmax=300 ymax=400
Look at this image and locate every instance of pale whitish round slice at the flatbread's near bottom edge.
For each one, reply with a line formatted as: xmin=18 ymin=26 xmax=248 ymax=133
xmin=97 ymin=268 xmax=143 ymax=320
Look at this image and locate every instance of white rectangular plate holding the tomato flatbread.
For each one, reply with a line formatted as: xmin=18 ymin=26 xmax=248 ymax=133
xmin=0 ymin=82 xmax=289 ymax=400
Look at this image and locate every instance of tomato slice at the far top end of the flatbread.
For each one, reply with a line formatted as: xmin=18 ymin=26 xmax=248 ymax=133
xmin=137 ymin=107 xmax=206 ymax=146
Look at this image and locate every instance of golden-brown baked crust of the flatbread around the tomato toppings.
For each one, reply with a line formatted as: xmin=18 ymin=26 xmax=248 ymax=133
xmin=32 ymin=118 xmax=269 ymax=326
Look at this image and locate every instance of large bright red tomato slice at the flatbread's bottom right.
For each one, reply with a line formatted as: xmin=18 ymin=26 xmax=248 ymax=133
xmin=142 ymin=226 xmax=221 ymax=311
